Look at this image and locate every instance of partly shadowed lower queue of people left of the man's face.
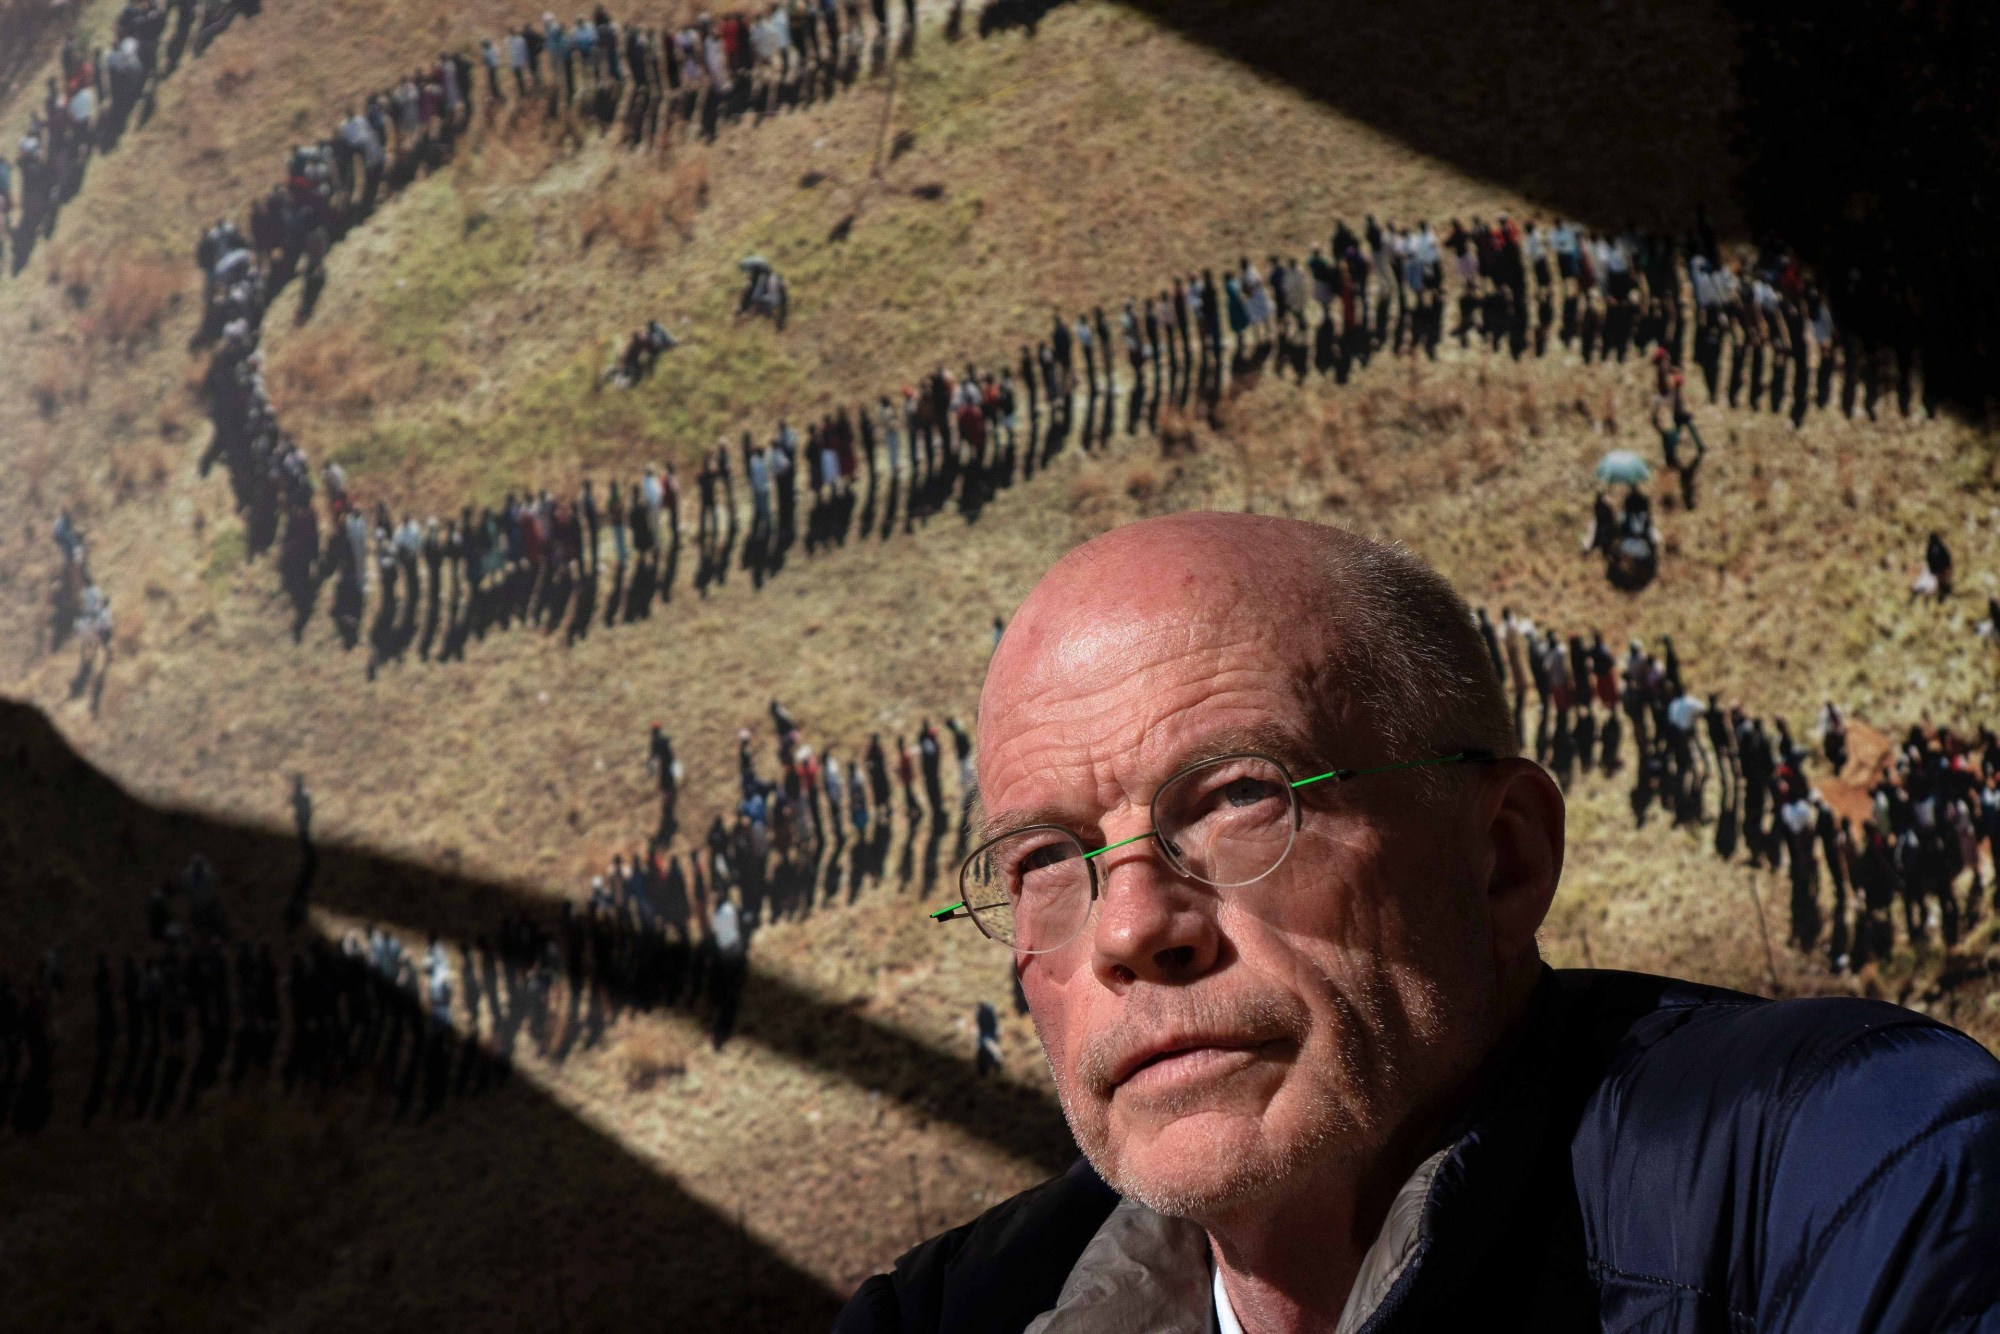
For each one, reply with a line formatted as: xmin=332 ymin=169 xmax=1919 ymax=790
xmin=0 ymin=688 xmax=972 ymax=1134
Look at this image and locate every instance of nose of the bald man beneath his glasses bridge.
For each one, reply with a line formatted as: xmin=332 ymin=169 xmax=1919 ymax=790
xmin=1092 ymin=834 xmax=1220 ymax=990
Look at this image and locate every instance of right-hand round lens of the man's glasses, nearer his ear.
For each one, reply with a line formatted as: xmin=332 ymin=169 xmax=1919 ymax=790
xmin=1152 ymin=756 xmax=1298 ymax=886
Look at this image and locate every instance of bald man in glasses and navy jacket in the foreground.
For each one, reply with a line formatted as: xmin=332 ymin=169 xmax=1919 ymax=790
xmin=836 ymin=514 xmax=2000 ymax=1334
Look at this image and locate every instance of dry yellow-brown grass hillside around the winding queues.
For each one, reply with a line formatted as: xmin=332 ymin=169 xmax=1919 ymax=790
xmin=0 ymin=0 xmax=2000 ymax=1328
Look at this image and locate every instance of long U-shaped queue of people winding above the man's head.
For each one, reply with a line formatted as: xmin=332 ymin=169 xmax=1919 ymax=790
xmin=11 ymin=0 xmax=1918 ymax=688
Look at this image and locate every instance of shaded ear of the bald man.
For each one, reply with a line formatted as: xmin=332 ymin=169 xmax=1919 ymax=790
xmin=1478 ymin=756 xmax=1568 ymax=982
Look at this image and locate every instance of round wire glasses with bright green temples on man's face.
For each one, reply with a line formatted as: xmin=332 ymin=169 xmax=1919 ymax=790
xmin=930 ymin=750 xmax=1494 ymax=954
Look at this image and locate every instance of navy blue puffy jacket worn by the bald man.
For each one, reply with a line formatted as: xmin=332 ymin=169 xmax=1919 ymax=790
xmin=836 ymin=970 xmax=2000 ymax=1334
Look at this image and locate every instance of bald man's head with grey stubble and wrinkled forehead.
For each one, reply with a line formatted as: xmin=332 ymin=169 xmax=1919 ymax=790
xmin=978 ymin=514 xmax=1562 ymax=1220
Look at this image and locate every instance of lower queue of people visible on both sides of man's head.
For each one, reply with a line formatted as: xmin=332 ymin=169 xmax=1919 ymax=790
xmin=0 ymin=608 xmax=2000 ymax=1132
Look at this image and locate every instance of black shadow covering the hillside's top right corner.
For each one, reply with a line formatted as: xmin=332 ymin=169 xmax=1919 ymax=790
xmin=1124 ymin=0 xmax=2000 ymax=412
